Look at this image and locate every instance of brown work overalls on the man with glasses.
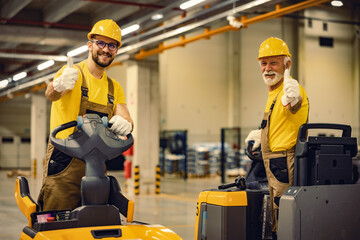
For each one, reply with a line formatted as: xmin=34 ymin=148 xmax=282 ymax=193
xmin=38 ymin=65 xmax=114 ymax=211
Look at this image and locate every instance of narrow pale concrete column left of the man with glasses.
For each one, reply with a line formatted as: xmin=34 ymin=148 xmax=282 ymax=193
xmin=30 ymin=94 xmax=47 ymax=179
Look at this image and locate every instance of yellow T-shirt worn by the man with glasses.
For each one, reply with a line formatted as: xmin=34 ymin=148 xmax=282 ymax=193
xmin=50 ymin=60 xmax=126 ymax=138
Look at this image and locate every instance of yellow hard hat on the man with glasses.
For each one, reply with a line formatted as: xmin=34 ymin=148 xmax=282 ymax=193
xmin=88 ymin=19 xmax=122 ymax=47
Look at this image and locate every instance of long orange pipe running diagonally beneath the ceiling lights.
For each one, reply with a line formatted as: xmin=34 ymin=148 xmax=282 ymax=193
xmin=135 ymin=0 xmax=329 ymax=60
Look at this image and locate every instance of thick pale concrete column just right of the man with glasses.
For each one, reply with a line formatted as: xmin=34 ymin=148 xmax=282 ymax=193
xmin=126 ymin=61 xmax=159 ymax=194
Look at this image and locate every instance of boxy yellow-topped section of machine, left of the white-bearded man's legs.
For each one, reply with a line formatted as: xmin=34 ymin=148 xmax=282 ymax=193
xmin=194 ymin=188 xmax=266 ymax=240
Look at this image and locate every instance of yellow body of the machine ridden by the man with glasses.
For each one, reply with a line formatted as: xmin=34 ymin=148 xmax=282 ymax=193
xmin=15 ymin=177 xmax=182 ymax=240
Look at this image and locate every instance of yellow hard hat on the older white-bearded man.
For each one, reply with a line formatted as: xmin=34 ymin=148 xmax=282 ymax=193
xmin=257 ymin=37 xmax=291 ymax=60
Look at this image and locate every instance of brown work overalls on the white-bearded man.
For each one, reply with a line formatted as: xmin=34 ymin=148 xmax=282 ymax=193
xmin=261 ymin=96 xmax=295 ymax=232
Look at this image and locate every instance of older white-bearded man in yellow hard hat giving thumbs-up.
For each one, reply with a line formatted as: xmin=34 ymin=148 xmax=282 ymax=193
xmin=245 ymin=37 xmax=309 ymax=239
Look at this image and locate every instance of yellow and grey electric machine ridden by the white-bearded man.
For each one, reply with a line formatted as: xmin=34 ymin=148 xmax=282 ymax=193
xmin=194 ymin=123 xmax=360 ymax=240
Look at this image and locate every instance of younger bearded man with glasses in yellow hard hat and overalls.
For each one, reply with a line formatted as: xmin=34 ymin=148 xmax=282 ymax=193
xmin=38 ymin=19 xmax=134 ymax=211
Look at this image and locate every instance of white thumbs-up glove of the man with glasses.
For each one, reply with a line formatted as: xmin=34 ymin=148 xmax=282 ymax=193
xmin=53 ymin=57 xmax=79 ymax=92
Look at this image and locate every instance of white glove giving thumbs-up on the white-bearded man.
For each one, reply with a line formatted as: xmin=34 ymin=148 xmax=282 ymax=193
xmin=281 ymin=69 xmax=300 ymax=107
